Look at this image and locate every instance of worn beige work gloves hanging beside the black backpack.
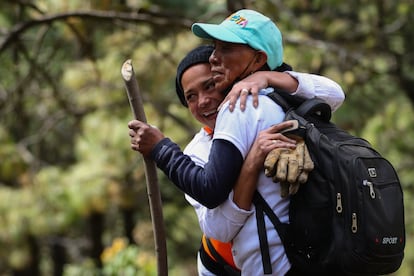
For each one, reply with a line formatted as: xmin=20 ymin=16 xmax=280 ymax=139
xmin=264 ymin=135 xmax=314 ymax=197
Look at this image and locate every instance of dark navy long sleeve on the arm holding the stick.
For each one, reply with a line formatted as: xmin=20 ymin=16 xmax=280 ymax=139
xmin=151 ymin=138 xmax=243 ymax=208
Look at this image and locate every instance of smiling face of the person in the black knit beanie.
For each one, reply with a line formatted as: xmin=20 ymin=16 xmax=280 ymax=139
xmin=181 ymin=63 xmax=224 ymax=129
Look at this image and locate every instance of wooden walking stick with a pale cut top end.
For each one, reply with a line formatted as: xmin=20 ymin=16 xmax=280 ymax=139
xmin=121 ymin=59 xmax=168 ymax=276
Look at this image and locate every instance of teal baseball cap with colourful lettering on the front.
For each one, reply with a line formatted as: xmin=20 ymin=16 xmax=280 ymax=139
xmin=191 ymin=9 xmax=283 ymax=70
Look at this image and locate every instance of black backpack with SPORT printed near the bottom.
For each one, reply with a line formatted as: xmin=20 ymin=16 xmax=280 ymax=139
xmin=254 ymin=91 xmax=405 ymax=275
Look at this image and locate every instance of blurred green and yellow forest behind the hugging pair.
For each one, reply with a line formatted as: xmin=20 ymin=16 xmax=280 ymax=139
xmin=0 ymin=0 xmax=414 ymax=276
